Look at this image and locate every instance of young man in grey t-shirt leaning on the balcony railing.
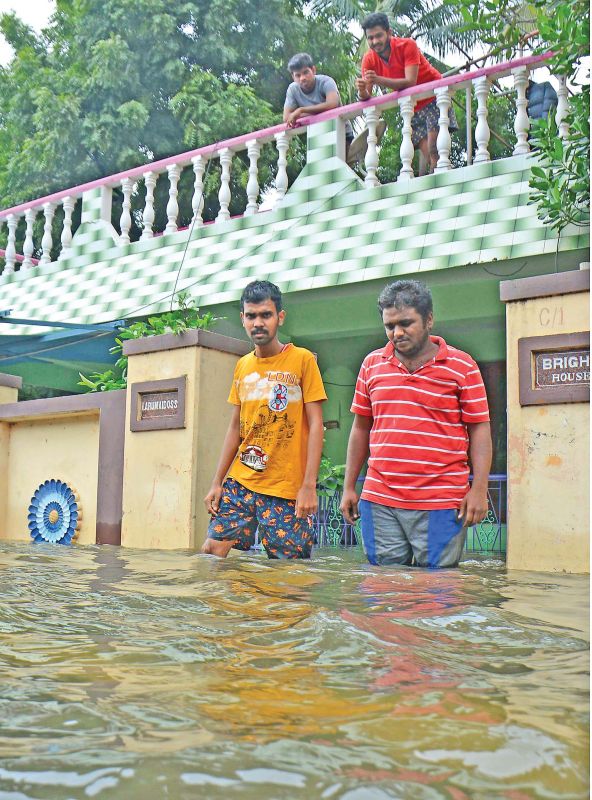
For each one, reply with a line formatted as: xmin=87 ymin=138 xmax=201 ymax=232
xmin=284 ymin=53 xmax=354 ymax=144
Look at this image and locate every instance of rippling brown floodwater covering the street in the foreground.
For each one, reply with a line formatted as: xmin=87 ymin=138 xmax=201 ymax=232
xmin=0 ymin=543 xmax=589 ymax=800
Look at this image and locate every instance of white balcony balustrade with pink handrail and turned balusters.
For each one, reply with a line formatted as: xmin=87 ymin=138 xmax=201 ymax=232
xmin=0 ymin=56 xmax=556 ymax=275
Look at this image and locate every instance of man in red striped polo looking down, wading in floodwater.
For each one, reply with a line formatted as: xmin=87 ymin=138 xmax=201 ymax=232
xmin=341 ymin=280 xmax=491 ymax=567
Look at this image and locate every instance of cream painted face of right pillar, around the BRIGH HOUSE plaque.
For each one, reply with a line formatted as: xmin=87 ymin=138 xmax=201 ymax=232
xmin=502 ymin=276 xmax=590 ymax=572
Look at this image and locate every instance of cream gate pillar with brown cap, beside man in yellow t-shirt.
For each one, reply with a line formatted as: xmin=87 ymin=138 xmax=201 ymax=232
xmin=121 ymin=330 xmax=251 ymax=549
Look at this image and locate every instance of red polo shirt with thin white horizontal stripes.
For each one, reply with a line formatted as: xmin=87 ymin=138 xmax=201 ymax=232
xmin=351 ymin=336 xmax=489 ymax=509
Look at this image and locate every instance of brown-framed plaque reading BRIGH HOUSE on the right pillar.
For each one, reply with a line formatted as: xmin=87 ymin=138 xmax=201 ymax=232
xmin=518 ymin=332 xmax=590 ymax=406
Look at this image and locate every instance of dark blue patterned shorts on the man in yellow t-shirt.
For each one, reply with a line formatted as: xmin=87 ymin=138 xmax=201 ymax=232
xmin=208 ymin=478 xmax=313 ymax=558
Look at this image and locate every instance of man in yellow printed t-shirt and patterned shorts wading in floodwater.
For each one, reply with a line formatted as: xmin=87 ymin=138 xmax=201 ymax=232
xmin=202 ymin=281 xmax=327 ymax=558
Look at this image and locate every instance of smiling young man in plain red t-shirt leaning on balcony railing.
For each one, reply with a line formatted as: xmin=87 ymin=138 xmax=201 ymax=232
xmin=356 ymin=12 xmax=458 ymax=172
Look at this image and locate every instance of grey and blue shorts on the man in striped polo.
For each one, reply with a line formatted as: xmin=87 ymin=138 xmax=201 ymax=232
xmin=359 ymin=500 xmax=467 ymax=569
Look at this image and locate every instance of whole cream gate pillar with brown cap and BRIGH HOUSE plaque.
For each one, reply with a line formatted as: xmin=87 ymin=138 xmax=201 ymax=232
xmin=500 ymin=270 xmax=590 ymax=572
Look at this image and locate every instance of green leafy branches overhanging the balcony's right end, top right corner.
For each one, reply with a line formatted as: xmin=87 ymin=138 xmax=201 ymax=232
xmin=448 ymin=0 xmax=590 ymax=232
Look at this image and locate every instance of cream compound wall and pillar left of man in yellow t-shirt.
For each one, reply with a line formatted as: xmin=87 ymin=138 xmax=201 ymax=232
xmin=0 ymin=331 xmax=250 ymax=549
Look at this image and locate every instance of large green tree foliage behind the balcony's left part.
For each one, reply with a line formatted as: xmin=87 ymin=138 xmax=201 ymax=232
xmin=0 ymin=0 xmax=353 ymax=207
